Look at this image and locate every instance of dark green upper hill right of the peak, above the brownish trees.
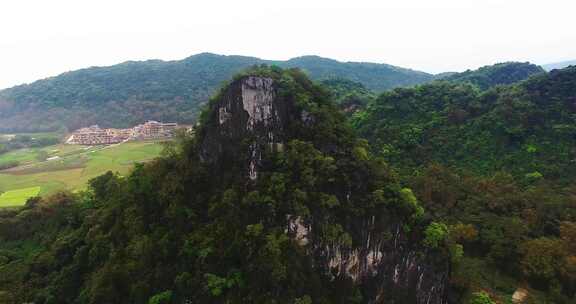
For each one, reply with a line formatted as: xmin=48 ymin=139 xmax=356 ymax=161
xmin=354 ymin=67 xmax=576 ymax=180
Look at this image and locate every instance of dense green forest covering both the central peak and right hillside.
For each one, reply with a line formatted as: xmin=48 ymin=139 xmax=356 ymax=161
xmin=0 ymin=67 xmax=576 ymax=304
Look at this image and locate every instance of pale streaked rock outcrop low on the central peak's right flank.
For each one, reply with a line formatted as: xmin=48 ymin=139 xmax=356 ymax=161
xmin=288 ymin=216 xmax=449 ymax=304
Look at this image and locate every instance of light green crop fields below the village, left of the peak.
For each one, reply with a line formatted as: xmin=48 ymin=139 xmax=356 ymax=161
xmin=0 ymin=141 xmax=163 ymax=201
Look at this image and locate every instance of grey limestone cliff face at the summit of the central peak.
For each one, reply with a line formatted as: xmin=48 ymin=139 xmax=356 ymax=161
xmin=201 ymin=76 xmax=294 ymax=180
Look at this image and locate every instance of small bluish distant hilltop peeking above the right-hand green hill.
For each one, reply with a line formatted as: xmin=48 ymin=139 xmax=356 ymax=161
xmin=436 ymin=62 xmax=545 ymax=90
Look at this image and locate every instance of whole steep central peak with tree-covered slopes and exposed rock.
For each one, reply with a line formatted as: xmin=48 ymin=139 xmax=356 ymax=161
xmin=0 ymin=68 xmax=450 ymax=304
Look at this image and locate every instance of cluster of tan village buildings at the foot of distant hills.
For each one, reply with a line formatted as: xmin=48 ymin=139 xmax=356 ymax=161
xmin=66 ymin=120 xmax=178 ymax=145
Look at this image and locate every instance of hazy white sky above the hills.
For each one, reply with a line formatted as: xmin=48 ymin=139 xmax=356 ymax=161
xmin=0 ymin=0 xmax=576 ymax=88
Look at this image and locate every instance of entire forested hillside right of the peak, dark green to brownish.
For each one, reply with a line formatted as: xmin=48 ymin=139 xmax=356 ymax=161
xmin=352 ymin=67 xmax=576 ymax=304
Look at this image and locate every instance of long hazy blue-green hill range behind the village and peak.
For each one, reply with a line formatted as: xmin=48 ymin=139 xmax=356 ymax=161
xmin=0 ymin=53 xmax=433 ymax=132
